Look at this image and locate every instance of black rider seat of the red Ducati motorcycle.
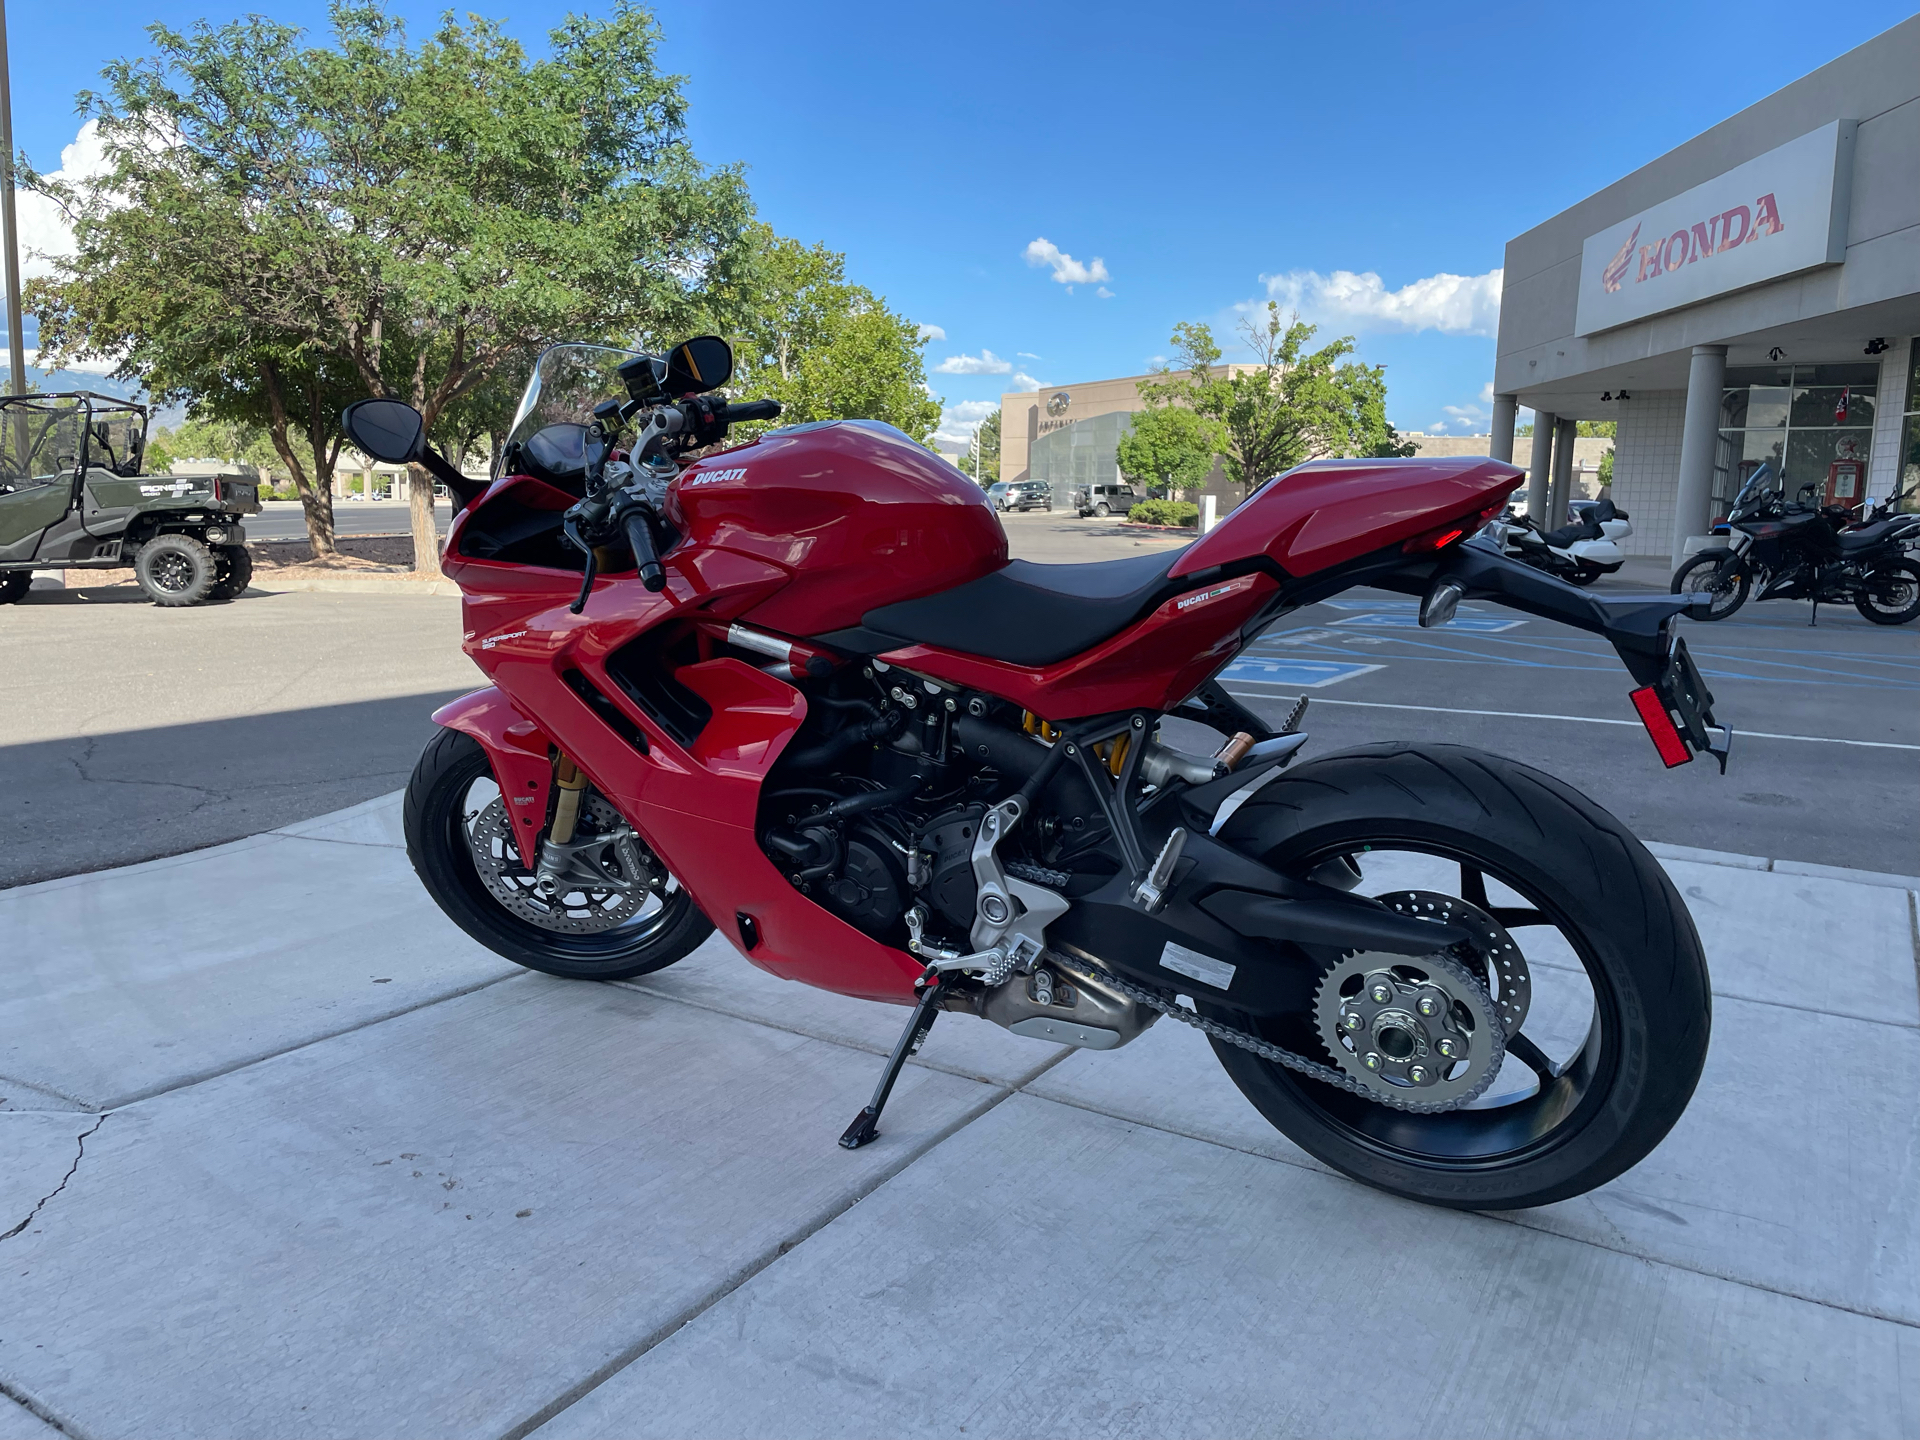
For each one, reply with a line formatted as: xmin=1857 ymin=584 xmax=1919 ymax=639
xmin=860 ymin=547 xmax=1185 ymax=664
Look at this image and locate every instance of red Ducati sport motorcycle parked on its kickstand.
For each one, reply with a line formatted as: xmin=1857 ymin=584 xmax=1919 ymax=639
xmin=344 ymin=338 xmax=1730 ymax=1208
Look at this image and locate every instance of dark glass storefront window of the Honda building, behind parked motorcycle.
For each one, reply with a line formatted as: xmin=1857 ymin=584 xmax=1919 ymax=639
xmin=1713 ymin=365 xmax=1881 ymax=515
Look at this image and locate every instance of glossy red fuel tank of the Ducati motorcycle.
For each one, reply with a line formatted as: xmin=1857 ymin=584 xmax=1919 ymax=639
xmin=668 ymin=420 xmax=1006 ymax=636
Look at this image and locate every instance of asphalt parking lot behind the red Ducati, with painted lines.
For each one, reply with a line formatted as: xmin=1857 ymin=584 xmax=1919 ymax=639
xmin=0 ymin=505 xmax=1920 ymax=887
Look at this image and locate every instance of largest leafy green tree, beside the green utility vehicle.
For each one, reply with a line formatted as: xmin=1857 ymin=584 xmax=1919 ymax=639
xmin=36 ymin=0 xmax=751 ymax=568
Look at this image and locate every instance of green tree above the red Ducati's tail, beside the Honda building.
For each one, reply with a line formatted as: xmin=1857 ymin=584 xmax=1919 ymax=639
xmin=1140 ymin=301 xmax=1407 ymax=490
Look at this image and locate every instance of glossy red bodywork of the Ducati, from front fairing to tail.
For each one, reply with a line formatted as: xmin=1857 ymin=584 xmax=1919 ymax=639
xmin=436 ymin=445 xmax=1519 ymax=1004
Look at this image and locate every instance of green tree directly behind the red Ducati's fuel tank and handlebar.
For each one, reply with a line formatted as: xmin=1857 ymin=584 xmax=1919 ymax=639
xmin=714 ymin=223 xmax=941 ymax=444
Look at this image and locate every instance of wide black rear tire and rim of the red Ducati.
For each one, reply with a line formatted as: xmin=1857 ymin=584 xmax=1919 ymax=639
xmin=1202 ymin=743 xmax=1711 ymax=1210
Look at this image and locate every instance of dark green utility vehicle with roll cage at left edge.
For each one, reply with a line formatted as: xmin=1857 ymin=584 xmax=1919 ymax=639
xmin=0 ymin=390 xmax=259 ymax=605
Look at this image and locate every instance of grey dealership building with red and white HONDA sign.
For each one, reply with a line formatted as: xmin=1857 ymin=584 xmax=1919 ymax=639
xmin=1492 ymin=17 xmax=1920 ymax=561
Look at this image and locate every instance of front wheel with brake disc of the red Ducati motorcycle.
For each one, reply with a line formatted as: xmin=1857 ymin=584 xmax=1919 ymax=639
xmin=403 ymin=730 xmax=712 ymax=979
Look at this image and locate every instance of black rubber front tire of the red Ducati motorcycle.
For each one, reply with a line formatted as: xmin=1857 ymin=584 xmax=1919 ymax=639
xmin=401 ymin=730 xmax=714 ymax=979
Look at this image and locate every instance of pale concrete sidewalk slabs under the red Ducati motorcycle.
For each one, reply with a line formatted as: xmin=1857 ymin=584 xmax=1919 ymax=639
xmin=0 ymin=797 xmax=1920 ymax=1440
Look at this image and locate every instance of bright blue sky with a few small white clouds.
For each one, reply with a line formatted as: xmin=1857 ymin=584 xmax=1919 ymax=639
xmin=8 ymin=0 xmax=1908 ymax=445
